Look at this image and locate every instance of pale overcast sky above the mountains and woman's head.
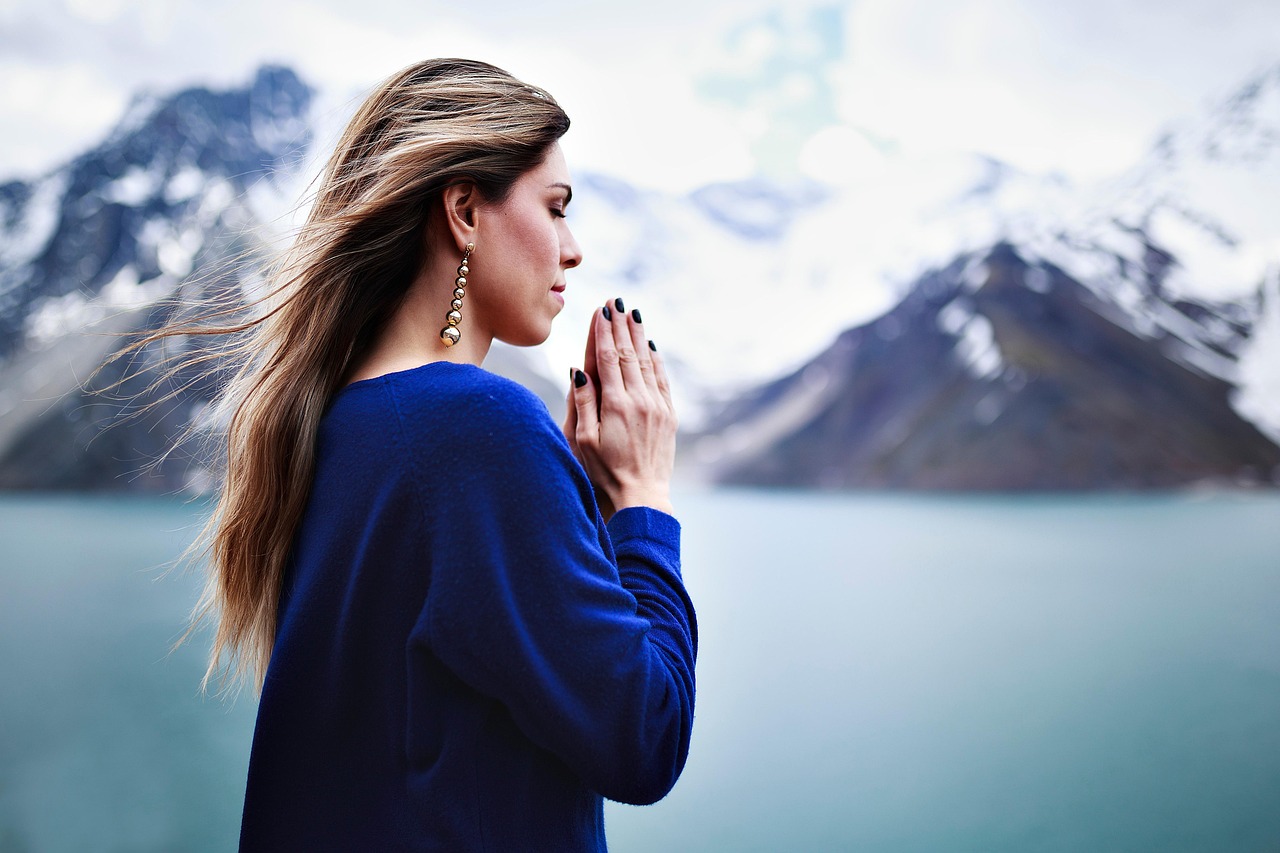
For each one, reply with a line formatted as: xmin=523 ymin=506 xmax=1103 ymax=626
xmin=0 ymin=0 xmax=1280 ymax=190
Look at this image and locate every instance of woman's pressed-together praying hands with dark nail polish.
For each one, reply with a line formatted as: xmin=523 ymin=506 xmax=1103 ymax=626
xmin=564 ymin=300 xmax=677 ymax=520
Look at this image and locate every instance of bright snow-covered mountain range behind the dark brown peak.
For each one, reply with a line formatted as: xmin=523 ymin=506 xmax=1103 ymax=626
xmin=564 ymin=65 xmax=1280 ymax=432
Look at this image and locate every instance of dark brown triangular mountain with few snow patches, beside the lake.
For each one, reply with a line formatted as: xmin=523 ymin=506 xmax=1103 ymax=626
xmin=701 ymin=245 xmax=1280 ymax=491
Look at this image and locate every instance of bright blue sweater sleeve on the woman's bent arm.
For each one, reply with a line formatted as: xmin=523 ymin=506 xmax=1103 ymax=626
xmin=399 ymin=376 xmax=698 ymax=804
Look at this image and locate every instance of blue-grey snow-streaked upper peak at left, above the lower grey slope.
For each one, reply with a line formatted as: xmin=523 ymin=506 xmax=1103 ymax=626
xmin=0 ymin=65 xmax=312 ymax=359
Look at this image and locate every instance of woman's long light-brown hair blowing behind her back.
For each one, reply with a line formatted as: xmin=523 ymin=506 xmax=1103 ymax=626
xmin=131 ymin=59 xmax=568 ymax=689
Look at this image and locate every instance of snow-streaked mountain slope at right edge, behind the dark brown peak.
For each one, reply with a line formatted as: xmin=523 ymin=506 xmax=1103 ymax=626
xmin=993 ymin=64 xmax=1280 ymax=441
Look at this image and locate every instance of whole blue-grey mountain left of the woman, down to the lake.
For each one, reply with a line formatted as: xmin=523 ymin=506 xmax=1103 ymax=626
xmin=0 ymin=67 xmax=312 ymax=491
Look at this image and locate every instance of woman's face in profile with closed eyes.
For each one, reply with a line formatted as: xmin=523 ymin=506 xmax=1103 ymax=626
xmin=473 ymin=145 xmax=582 ymax=347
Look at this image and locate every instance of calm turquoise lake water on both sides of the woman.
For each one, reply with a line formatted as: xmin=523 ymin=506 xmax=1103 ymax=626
xmin=0 ymin=491 xmax=1280 ymax=853
